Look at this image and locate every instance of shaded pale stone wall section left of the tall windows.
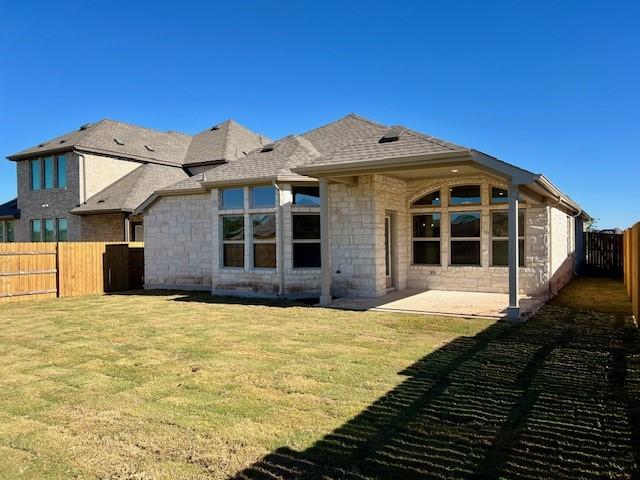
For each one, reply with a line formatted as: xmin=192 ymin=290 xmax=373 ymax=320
xmin=144 ymin=194 xmax=213 ymax=290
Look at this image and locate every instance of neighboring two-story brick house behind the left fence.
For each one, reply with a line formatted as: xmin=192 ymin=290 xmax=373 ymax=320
xmin=0 ymin=120 xmax=270 ymax=242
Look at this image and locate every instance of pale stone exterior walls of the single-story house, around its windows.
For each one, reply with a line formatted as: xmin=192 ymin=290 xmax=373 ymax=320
xmin=145 ymin=175 xmax=572 ymax=297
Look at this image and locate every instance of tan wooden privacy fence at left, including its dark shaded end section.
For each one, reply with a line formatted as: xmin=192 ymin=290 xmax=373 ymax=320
xmin=0 ymin=242 xmax=144 ymax=303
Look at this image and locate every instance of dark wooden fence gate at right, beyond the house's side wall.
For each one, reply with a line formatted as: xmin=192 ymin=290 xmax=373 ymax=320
xmin=584 ymin=232 xmax=624 ymax=278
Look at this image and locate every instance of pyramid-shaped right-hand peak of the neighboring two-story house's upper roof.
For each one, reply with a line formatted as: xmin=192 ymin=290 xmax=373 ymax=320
xmin=184 ymin=119 xmax=271 ymax=166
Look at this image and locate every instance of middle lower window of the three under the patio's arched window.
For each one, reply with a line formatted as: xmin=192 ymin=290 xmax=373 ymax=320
xmin=450 ymin=212 xmax=481 ymax=265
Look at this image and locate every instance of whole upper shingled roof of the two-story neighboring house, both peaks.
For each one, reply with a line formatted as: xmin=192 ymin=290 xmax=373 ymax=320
xmin=8 ymin=119 xmax=270 ymax=166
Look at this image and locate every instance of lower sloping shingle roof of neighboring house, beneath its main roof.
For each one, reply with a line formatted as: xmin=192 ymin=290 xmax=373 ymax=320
xmin=71 ymin=163 xmax=188 ymax=215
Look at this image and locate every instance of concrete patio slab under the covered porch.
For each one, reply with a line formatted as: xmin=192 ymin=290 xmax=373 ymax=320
xmin=329 ymin=289 xmax=546 ymax=319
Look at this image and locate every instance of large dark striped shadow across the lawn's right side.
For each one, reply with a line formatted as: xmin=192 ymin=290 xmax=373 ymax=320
xmin=234 ymin=306 xmax=640 ymax=480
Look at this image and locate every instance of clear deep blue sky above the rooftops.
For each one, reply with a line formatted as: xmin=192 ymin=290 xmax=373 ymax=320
xmin=0 ymin=0 xmax=640 ymax=227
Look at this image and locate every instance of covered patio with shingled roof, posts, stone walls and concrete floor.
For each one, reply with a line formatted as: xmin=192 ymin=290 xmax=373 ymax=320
xmin=295 ymin=134 xmax=581 ymax=321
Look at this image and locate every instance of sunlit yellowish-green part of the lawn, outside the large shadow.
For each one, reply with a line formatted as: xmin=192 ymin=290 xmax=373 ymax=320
xmin=0 ymin=294 xmax=493 ymax=479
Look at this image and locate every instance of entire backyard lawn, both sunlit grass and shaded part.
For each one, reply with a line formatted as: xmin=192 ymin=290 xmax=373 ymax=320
xmin=0 ymin=286 xmax=640 ymax=479
